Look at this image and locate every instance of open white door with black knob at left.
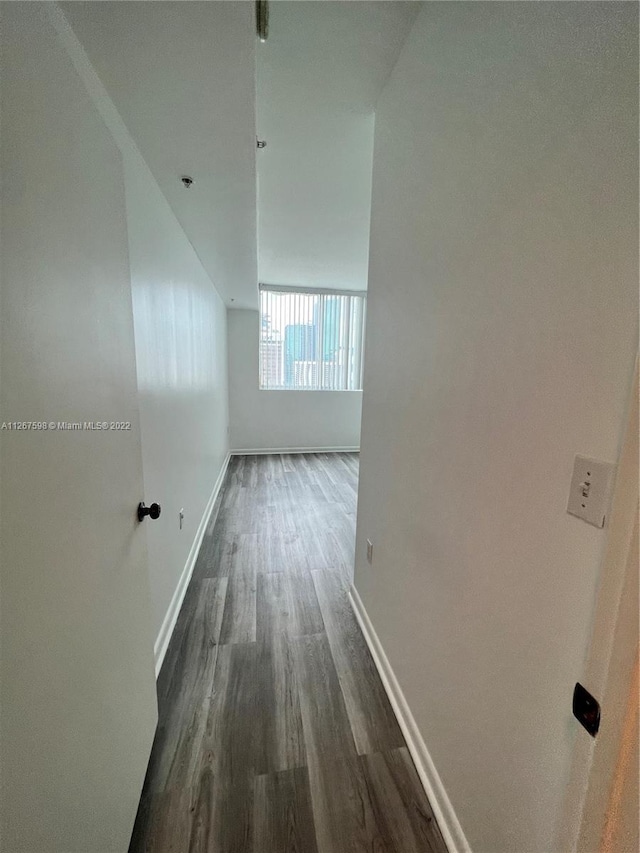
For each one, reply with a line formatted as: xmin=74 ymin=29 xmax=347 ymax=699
xmin=0 ymin=3 xmax=157 ymax=853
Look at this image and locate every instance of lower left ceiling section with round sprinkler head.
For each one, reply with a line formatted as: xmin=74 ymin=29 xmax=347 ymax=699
xmin=61 ymin=0 xmax=257 ymax=306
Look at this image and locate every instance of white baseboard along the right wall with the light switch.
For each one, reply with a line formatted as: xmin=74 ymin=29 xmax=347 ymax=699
xmin=349 ymin=584 xmax=472 ymax=853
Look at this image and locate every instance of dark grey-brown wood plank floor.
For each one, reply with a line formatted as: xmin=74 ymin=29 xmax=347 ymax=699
xmin=130 ymin=453 xmax=446 ymax=853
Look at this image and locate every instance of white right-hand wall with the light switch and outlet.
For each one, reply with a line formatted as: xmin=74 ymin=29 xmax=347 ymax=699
xmin=355 ymin=3 xmax=638 ymax=853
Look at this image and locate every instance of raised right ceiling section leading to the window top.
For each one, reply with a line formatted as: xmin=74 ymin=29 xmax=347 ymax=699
xmin=257 ymin=0 xmax=420 ymax=290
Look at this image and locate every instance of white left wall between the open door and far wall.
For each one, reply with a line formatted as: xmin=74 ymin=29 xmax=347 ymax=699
xmin=50 ymin=7 xmax=228 ymax=637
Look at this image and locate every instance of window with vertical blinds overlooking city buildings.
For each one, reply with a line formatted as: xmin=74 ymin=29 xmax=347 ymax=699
xmin=259 ymin=285 xmax=366 ymax=391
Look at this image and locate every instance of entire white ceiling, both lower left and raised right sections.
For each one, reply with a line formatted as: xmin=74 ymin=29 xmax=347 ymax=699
xmin=61 ymin=0 xmax=420 ymax=307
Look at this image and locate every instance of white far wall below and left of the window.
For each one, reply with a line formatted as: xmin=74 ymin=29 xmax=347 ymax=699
xmin=227 ymin=309 xmax=362 ymax=450
